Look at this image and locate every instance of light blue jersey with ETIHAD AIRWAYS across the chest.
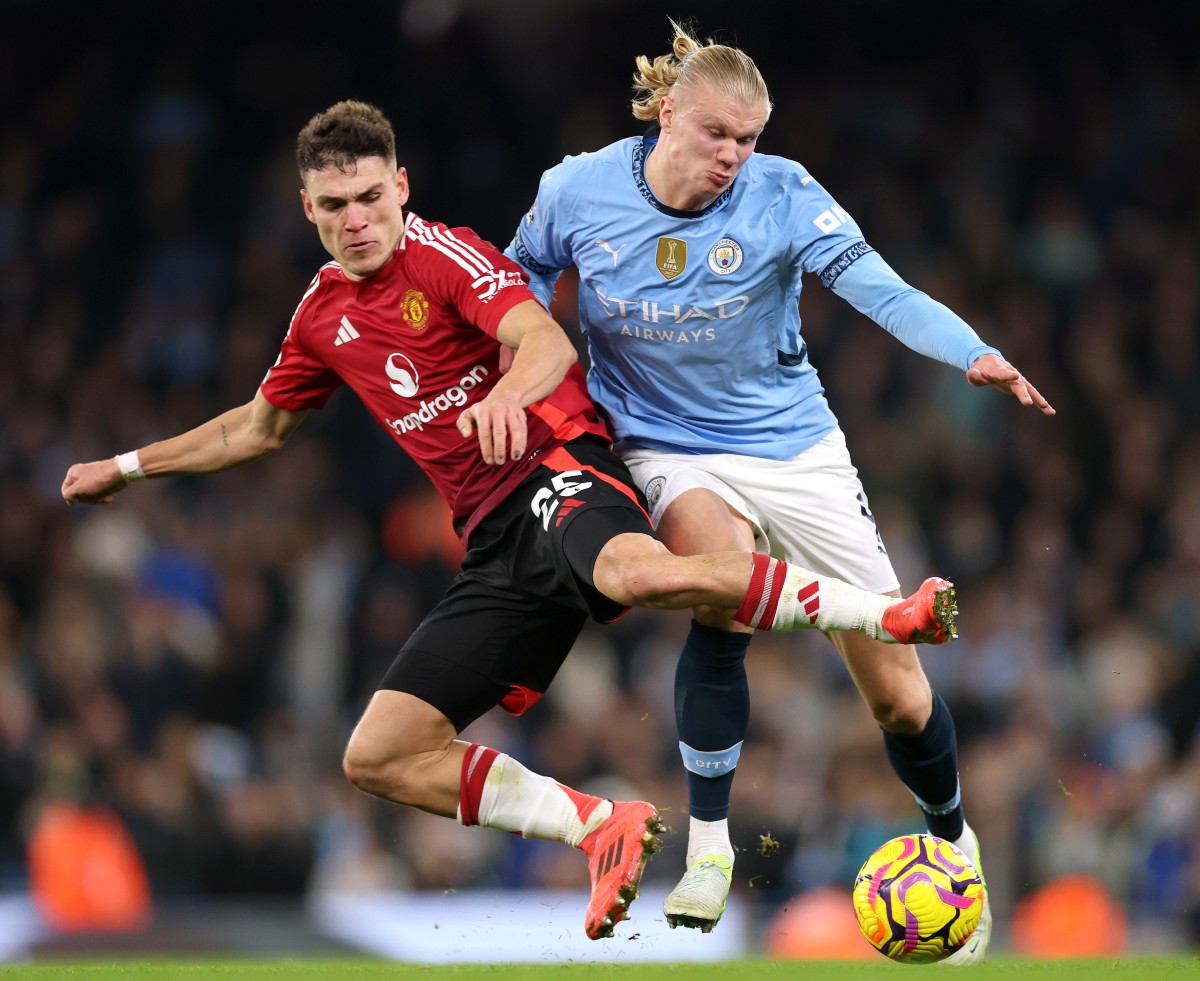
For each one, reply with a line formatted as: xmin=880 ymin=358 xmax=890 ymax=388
xmin=506 ymin=133 xmax=997 ymax=459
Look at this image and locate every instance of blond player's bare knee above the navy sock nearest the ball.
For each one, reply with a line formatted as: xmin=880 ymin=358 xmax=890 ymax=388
xmin=828 ymin=631 xmax=934 ymax=734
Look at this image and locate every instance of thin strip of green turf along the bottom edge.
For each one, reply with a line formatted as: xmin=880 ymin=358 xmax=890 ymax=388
xmin=0 ymin=957 xmax=1200 ymax=981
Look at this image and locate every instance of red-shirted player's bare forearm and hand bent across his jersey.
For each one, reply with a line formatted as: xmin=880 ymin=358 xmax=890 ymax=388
xmin=458 ymin=300 xmax=578 ymax=464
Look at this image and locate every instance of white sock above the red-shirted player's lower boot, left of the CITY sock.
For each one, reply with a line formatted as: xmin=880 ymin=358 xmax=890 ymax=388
xmin=460 ymin=753 xmax=613 ymax=848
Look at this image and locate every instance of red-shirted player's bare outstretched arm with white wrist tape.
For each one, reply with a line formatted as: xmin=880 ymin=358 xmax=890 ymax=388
xmin=62 ymin=391 xmax=307 ymax=504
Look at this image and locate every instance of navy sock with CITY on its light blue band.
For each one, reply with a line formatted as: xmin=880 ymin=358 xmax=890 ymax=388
xmin=676 ymin=620 xmax=751 ymax=821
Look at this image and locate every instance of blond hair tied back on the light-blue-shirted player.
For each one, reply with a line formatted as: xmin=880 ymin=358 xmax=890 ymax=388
xmin=631 ymin=20 xmax=772 ymax=122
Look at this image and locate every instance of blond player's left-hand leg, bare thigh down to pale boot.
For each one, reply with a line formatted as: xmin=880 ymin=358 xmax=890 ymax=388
xmin=658 ymin=487 xmax=754 ymax=933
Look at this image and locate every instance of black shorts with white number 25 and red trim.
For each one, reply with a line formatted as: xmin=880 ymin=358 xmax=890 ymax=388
xmin=379 ymin=437 xmax=656 ymax=732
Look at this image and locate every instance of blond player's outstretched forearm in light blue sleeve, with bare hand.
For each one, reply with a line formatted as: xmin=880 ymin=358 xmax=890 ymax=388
xmin=830 ymin=252 xmax=1055 ymax=415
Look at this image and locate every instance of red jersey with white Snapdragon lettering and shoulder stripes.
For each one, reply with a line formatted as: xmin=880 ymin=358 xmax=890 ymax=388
xmin=262 ymin=213 xmax=611 ymax=542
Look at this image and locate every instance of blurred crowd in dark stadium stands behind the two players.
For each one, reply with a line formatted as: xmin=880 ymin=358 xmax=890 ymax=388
xmin=0 ymin=0 xmax=1200 ymax=949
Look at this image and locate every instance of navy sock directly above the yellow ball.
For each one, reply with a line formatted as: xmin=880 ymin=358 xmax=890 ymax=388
xmin=883 ymin=692 xmax=962 ymax=841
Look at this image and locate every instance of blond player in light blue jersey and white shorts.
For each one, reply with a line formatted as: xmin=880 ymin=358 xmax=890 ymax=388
xmin=508 ymin=22 xmax=1054 ymax=963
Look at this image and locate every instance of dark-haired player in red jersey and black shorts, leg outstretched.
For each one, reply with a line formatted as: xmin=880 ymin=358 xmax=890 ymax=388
xmin=62 ymin=102 xmax=955 ymax=938
